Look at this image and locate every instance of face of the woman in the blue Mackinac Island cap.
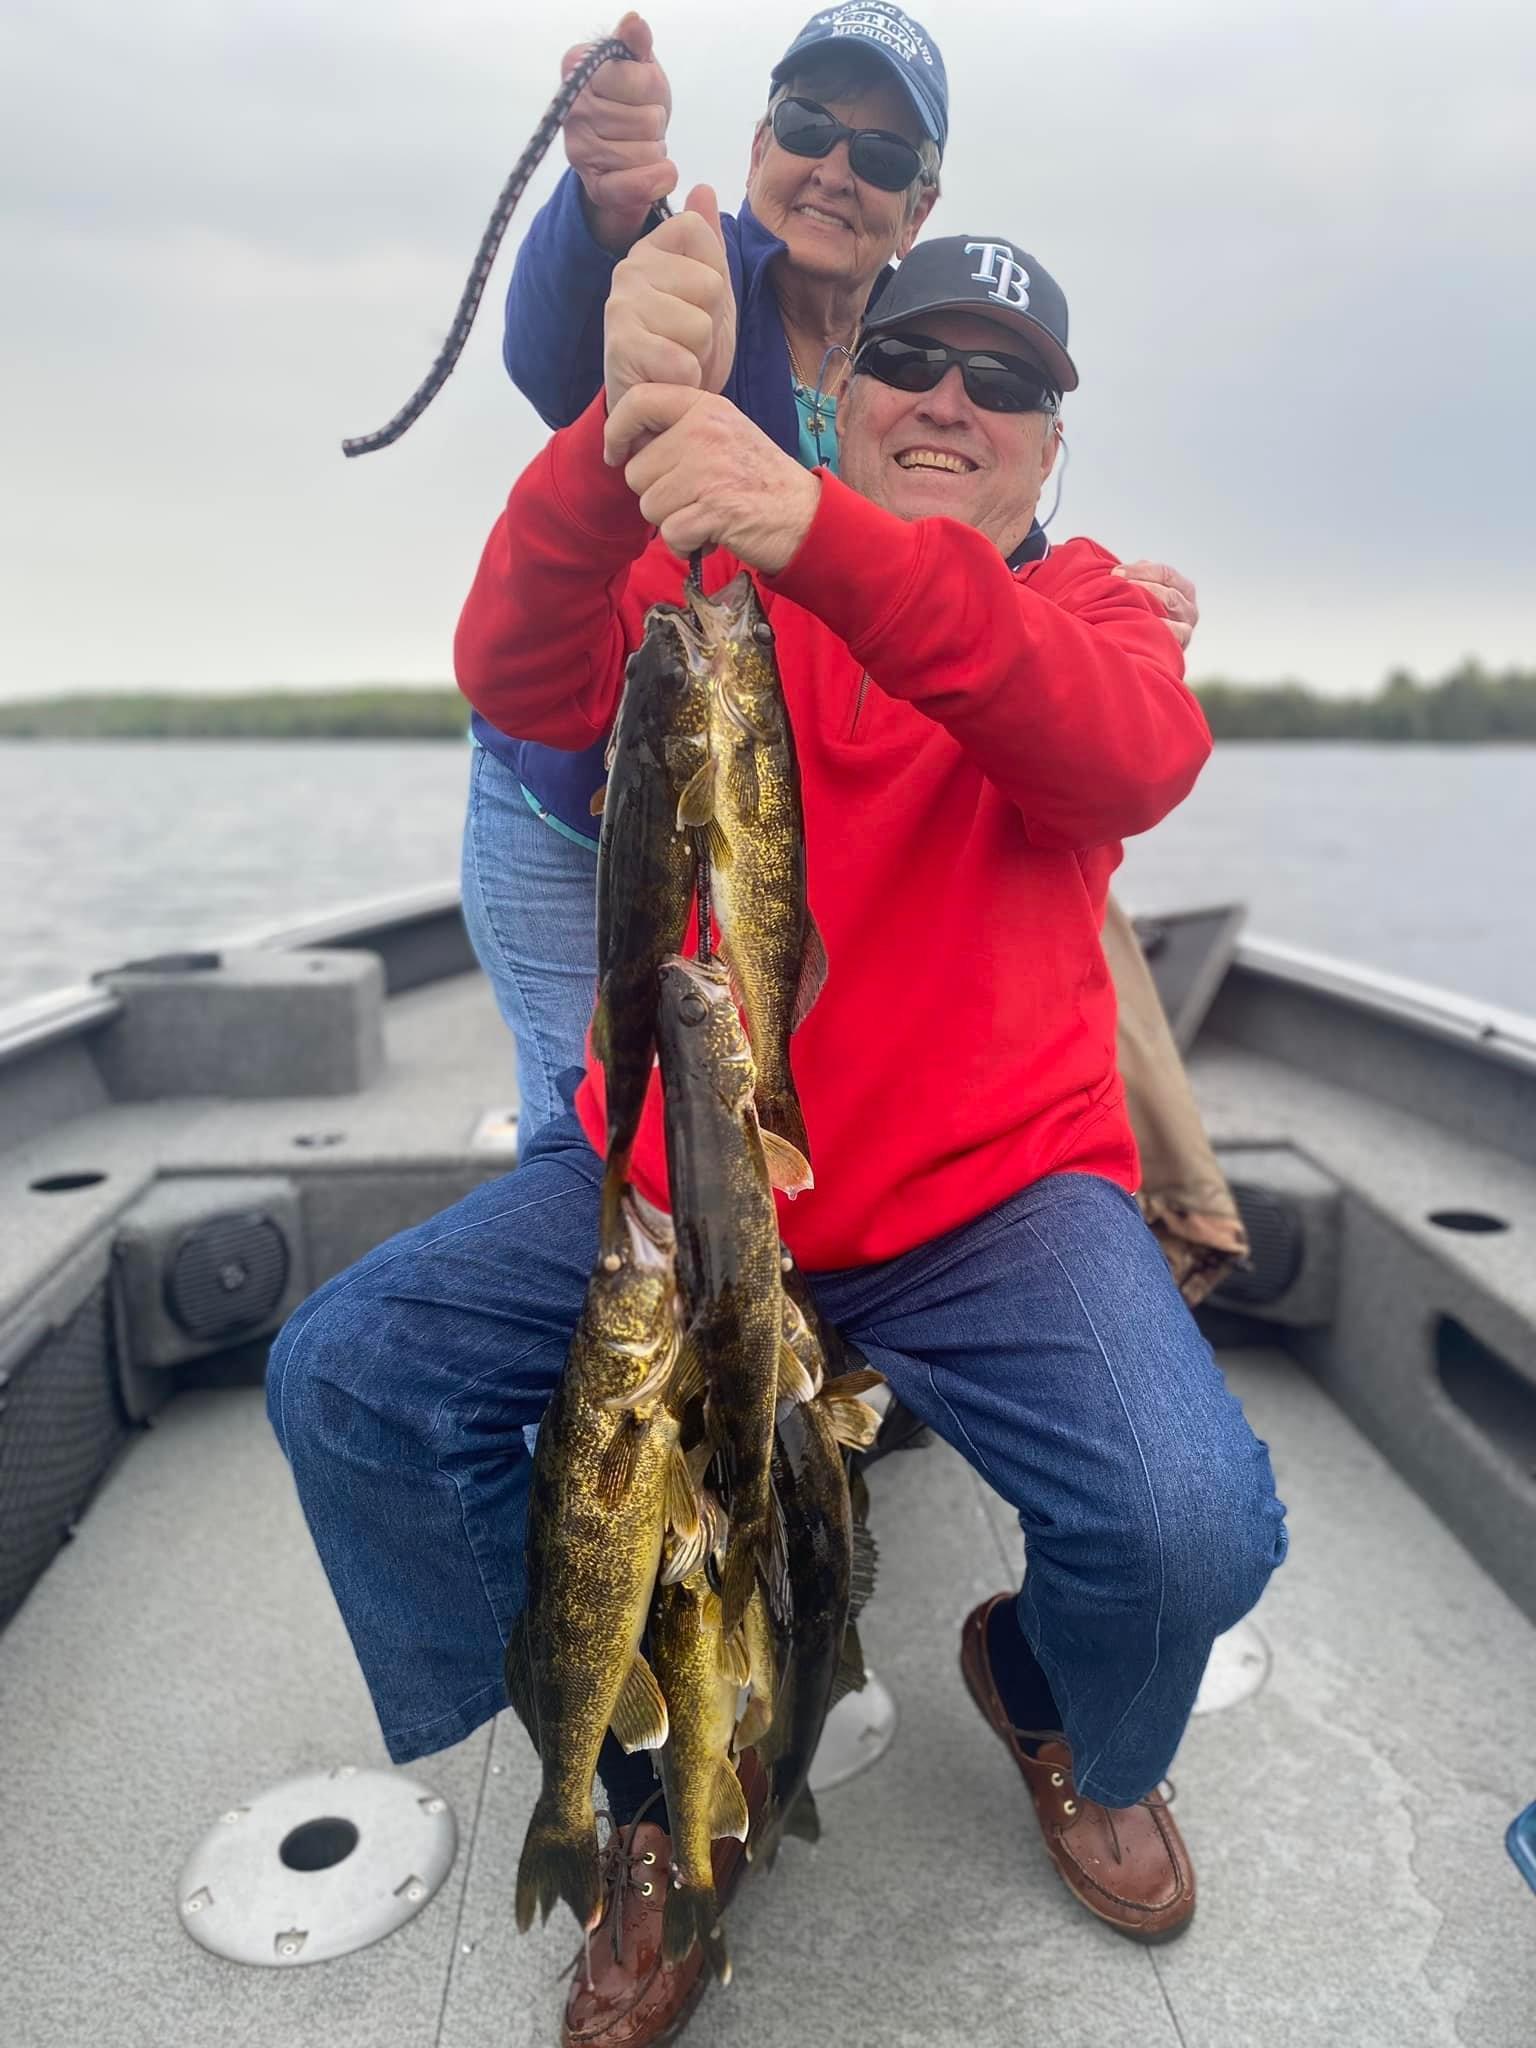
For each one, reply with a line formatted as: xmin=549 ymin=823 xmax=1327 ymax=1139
xmin=748 ymin=74 xmax=938 ymax=291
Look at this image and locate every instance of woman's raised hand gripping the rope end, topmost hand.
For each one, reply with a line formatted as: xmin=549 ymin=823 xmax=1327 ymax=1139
xmin=559 ymin=14 xmax=678 ymax=254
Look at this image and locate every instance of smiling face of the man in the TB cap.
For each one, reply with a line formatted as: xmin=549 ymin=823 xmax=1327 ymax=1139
xmin=838 ymin=313 xmax=1057 ymax=553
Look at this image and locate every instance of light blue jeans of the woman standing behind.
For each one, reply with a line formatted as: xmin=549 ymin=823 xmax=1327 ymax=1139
xmin=461 ymin=741 xmax=598 ymax=1143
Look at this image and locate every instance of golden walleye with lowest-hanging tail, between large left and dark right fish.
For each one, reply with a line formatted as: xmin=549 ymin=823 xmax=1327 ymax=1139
xmin=651 ymin=1507 xmax=750 ymax=1982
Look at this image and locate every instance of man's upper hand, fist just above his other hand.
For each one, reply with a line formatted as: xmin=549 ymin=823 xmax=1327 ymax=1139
xmin=602 ymin=184 xmax=735 ymax=421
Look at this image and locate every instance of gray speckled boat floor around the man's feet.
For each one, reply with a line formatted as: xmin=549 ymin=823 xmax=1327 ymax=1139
xmin=0 ymin=1350 xmax=1536 ymax=2048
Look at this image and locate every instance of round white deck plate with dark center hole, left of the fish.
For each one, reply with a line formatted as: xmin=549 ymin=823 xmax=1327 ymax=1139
xmin=176 ymin=1763 xmax=459 ymax=1968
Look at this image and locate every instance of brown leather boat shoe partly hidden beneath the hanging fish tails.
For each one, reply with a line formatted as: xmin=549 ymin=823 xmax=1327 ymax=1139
xmin=561 ymin=1749 xmax=768 ymax=2048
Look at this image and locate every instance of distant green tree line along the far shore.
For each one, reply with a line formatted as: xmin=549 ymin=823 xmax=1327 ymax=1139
xmin=0 ymin=662 xmax=1536 ymax=743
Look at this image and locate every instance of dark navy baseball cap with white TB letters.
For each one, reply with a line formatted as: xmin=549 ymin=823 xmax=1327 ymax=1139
xmin=860 ymin=236 xmax=1077 ymax=391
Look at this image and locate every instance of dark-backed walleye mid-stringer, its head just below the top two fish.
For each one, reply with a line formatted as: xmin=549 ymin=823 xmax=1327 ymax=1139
xmin=655 ymin=958 xmax=813 ymax=1634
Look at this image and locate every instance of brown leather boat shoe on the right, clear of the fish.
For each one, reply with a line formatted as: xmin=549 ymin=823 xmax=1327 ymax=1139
xmin=961 ymin=1593 xmax=1194 ymax=1942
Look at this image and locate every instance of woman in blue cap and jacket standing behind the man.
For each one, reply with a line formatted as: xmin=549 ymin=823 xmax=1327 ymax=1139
xmin=463 ymin=4 xmax=1241 ymax=1294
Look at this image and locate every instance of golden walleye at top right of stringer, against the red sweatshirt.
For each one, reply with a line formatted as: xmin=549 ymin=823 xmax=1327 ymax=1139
xmin=678 ymin=571 xmax=827 ymax=1194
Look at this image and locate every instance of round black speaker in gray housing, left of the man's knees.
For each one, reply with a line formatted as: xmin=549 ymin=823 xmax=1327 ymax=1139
xmin=113 ymin=1176 xmax=307 ymax=1413
